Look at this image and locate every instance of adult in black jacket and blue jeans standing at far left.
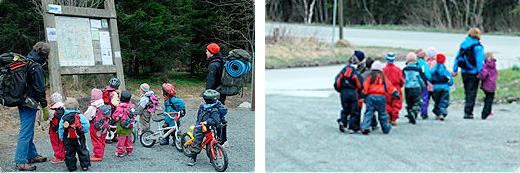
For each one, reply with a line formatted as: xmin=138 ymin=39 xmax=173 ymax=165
xmin=14 ymin=42 xmax=50 ymax=171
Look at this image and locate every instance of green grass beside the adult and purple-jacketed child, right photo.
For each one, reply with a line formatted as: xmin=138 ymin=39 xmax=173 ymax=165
xmin=450 ymin=66 xmax=520 ymax=103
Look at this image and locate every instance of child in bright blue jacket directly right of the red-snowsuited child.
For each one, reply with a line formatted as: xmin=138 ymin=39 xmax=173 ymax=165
xmin=403 ymin=52 xmax=428 ymax=124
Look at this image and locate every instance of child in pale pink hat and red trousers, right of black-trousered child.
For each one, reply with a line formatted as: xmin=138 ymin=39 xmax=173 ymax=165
xmin=85 ymin=88 xmax=112 ymax=162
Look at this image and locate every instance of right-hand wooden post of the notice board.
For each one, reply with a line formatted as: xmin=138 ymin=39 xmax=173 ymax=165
xmin=105 ymin=0 xmax=126 ymax=91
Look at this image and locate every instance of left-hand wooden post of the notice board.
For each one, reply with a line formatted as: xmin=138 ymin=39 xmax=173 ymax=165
xmin=42 ymin=0 xmax=66 ymax=96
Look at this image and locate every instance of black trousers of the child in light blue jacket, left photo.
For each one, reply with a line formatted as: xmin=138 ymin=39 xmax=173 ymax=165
xmin=63 ymin=134 xmax=90 ymax=171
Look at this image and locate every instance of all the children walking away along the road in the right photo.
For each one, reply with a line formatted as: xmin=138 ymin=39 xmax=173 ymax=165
xmin=334 ymin=47 xmax=498 ymax=134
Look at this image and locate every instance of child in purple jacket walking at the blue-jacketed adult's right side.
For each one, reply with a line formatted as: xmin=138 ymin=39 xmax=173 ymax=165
xmin=477 ymin=52 xmax=498 ymax=120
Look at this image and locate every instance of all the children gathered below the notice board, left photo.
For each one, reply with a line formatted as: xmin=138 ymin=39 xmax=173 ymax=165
xmin=49 ymin=78 xmax=225 ymax=171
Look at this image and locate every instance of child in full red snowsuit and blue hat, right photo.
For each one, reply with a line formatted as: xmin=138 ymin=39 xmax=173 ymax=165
xmin=383 ymin=52 xmax=404 ymax=126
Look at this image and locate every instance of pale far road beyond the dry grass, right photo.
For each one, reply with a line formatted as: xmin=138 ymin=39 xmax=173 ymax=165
xmin=265 ymin=22 xmax=520 ymax=69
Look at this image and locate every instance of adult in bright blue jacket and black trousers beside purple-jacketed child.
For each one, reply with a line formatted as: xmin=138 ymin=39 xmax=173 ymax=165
xmin=453 ymin=28 xmax=484 ymax=119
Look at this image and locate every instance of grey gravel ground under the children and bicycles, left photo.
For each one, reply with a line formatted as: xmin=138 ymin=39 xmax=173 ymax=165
xmin=0 ymin=110 xmax=255 ymax=172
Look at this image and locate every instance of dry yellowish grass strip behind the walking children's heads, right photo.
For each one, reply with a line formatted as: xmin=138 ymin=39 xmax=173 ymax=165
xmin=265 ymin=38 xmax=413 ymax=69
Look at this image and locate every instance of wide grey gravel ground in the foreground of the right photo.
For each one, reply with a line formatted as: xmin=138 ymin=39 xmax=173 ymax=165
xmin=265 ymin=94 xmax=520 ymax=172
